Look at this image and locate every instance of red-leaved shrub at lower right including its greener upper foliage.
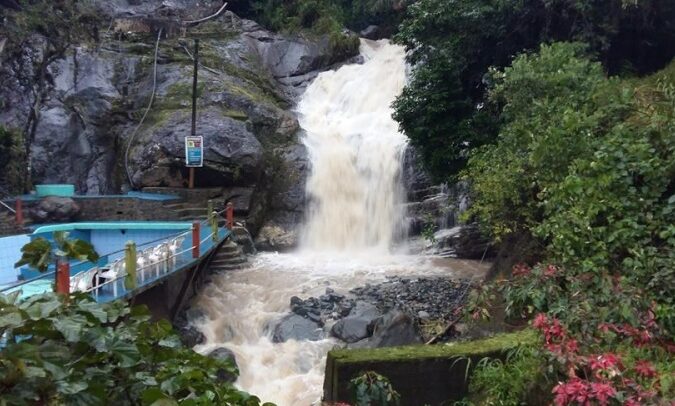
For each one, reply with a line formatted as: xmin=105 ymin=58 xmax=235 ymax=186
xmin=467 ymin=264 xmax=675 ymax=405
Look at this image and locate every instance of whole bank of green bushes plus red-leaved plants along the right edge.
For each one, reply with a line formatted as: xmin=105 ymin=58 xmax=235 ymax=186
xmin=464 ymin=43 xmax=675 ymax=405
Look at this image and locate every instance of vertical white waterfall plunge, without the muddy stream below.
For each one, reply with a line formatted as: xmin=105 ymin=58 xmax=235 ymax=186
xmin=298 ymin=40 xmax=407 ymax=252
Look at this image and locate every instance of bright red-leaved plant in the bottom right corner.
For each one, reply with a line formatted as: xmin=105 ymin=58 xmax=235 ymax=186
xmin=532 ymin=313 xmax=674 ymax=406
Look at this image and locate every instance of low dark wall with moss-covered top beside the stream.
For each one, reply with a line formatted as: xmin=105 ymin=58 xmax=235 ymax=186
xmin=324 ymin=330 xmax=537 ymax=405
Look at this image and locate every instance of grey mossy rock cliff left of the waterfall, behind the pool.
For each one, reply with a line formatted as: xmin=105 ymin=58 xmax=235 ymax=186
xmin=0 ymin=0 xmax=358 ymax=248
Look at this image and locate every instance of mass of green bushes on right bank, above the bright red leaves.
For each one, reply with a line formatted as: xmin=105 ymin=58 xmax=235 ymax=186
xmin=465 ymin=44 xmax=675 ymax=334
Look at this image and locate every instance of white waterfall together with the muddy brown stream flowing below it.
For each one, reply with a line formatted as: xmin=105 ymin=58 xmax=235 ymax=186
xmin=196 ymin=41 xmax=492 ymax=406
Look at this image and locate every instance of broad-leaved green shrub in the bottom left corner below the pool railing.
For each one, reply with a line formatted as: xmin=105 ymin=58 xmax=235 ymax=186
xmin=0 ymin=293 xmax=270 ymax=406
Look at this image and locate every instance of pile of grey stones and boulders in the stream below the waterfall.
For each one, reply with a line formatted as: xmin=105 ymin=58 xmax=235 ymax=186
xmin=273 ymin=277 xmax=471 ymax=347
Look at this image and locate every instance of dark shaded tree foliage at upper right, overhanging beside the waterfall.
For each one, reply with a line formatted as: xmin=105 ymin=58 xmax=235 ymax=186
xmin=394 ymin=0 xmax=675 ymax=179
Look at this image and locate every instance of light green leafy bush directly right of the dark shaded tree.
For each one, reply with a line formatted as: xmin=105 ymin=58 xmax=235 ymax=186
xmin=464 ymin=44 xmax=623 ymax=238
